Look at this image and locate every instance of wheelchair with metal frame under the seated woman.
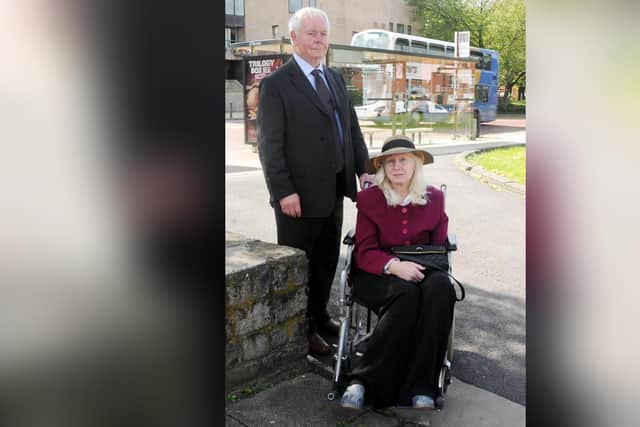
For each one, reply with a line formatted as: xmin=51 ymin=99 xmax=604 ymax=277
xmin=327 ymin=184 xmax=458 ymax=409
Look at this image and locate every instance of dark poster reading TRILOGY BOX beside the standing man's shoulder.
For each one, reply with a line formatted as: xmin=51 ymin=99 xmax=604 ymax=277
xmin=244 ymin=55 xmax=288 ymax=144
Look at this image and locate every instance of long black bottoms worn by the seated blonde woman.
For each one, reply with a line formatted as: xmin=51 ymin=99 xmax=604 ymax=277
xmin=350 ymin=270 xmax=455 ymax=407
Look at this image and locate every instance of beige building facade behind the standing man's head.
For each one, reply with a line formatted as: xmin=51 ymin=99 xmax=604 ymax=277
xmin=225 ymin=0 xmax=421 ymax=46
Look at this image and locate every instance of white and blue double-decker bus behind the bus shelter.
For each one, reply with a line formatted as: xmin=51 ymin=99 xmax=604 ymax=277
xmin=351 ymin=29 xmax=498 ymax=123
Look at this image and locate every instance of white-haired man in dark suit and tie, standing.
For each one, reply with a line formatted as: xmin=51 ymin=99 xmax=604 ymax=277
xmin=257 ymin=7 xmax=373 ymax=355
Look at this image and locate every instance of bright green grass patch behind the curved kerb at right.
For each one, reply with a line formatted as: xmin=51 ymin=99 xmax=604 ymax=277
xmin=467 ymin=146 xmax=527 ymax=185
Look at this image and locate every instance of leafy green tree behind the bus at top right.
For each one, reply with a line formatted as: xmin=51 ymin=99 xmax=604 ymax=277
xmin=406 ymin=0 xmax=526 ymax=100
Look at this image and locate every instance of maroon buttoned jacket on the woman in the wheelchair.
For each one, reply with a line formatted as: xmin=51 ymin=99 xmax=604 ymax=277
xmin=355 ymin=186 xmax=449 ymax=276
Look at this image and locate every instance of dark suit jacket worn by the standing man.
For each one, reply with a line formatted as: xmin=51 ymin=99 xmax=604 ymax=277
xmin=257 ymin=58 xmax=369 ymax=217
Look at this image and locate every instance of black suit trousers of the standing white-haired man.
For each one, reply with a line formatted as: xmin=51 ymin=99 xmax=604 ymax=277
xmin=274 ymin=173 xmax=344 ymax=334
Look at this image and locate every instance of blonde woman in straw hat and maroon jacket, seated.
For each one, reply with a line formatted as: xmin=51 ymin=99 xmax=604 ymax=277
xmin=341 ymin=136 xmax=455 ymax=409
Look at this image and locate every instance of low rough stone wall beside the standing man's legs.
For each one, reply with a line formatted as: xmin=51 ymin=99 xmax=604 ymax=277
xmin=225 ymin=233 xmax=307 ymax=391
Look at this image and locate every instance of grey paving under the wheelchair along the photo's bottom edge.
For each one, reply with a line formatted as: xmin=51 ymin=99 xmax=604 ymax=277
xmin=226 ymin=373 xmax=525 ymax=427
